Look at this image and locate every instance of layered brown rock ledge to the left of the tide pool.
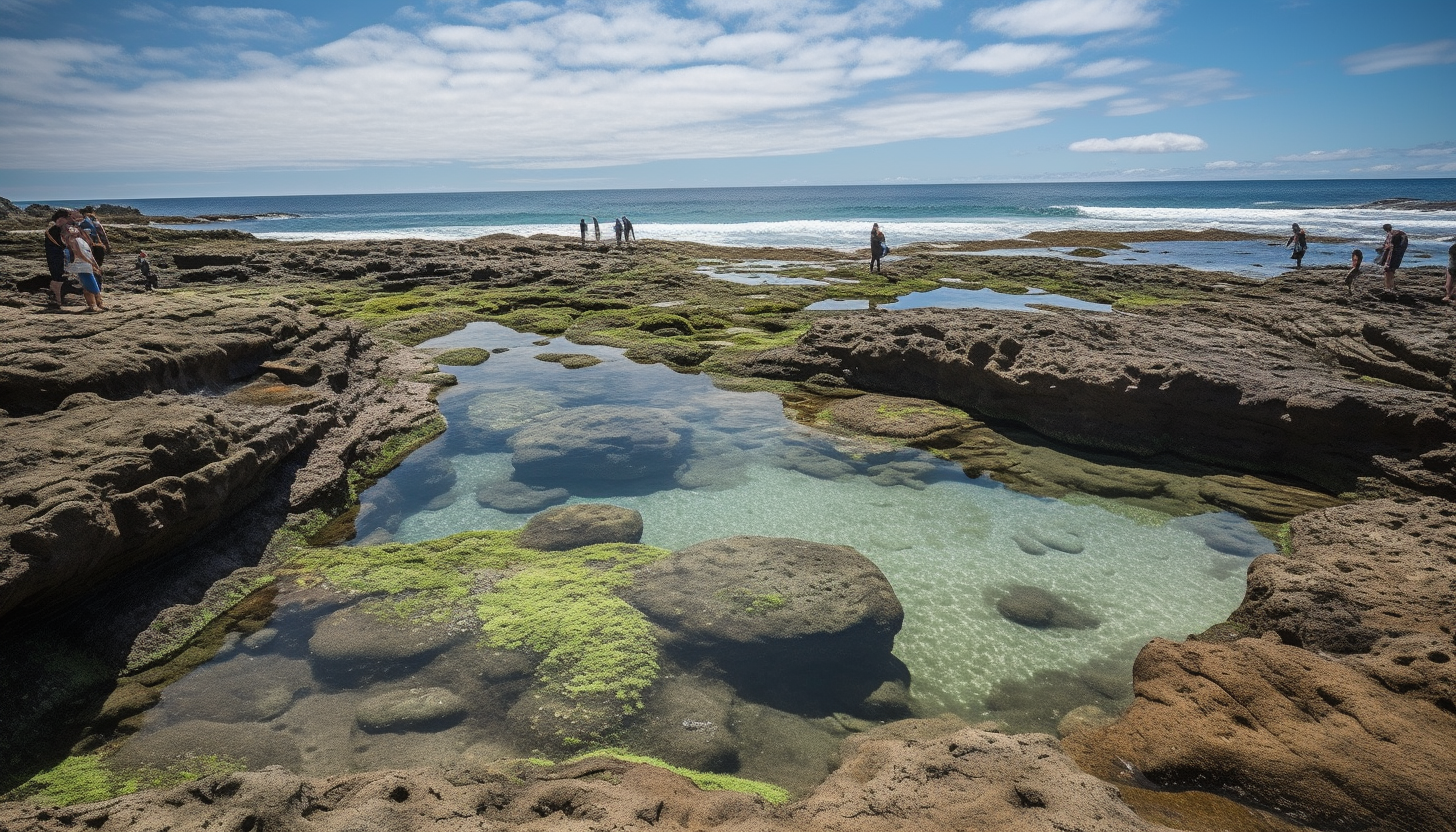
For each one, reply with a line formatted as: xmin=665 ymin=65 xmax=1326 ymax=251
xmin=0 ymin=296 xmax=435 ymax=616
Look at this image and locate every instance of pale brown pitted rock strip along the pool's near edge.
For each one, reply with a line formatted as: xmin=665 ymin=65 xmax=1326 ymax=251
xmin=0 ymin=723 xmax=1165 ymax=832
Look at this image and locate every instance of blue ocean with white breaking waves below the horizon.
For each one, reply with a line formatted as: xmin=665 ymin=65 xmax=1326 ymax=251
xmin=105 ymin=179 xmax=1456 ymax=251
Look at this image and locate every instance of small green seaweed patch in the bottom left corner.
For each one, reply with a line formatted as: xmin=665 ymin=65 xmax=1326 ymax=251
xmin=0 ymin=755 xmax=248 ymax=806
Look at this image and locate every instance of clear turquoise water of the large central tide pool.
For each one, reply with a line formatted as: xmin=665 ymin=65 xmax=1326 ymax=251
xmin=358 ymin=323 xmax=1273 ymax=718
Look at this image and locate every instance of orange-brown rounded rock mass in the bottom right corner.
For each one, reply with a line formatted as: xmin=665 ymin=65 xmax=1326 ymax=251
xmin=1066 ymin=498 xmax=1456 ymax=832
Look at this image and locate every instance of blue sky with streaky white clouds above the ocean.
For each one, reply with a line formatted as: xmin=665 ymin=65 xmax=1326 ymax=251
xmin=0 ymin=0 xmax=1456 ymax=201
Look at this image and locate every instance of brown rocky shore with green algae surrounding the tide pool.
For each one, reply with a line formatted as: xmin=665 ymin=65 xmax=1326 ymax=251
xmin=0 ymin=203 xmax=1456 ymax=831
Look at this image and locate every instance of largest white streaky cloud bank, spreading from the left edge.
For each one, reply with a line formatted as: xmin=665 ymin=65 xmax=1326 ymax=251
xmin=0 ymin=11 xmax=1125 ymax=170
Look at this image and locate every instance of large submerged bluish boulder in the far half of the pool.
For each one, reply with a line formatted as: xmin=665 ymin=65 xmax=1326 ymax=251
xmin=510 ymin=405 xmax=692 ymax=485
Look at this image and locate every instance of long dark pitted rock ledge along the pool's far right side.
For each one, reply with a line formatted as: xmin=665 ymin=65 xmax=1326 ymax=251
xmin=741 ymin=307 xmax=1456 ymax=497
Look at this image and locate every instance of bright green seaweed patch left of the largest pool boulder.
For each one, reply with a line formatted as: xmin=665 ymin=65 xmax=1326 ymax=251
xmin=290 ymin=532 xmax=670 ymax=718
